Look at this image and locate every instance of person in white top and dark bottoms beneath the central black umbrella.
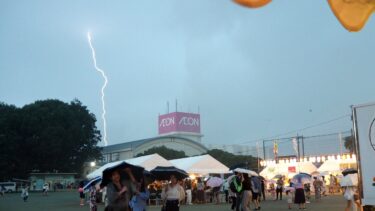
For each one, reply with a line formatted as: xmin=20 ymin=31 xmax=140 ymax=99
xmin=161 ymin=175 xmax=185 ymax=211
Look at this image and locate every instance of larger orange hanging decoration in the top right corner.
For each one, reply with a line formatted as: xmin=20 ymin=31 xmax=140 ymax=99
xmin=328 ymin=0 xmax=375 ymax=32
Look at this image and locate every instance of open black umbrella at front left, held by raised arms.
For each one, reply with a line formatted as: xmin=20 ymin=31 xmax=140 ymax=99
xmin=100 ymin=161 xmax=144 ymax=187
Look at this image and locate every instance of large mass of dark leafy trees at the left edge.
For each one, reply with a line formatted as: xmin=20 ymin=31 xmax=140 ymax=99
xmin=0 ymin=100 xmax=101 ymax=179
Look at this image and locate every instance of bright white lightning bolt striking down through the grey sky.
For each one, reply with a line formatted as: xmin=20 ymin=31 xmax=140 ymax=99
xmin=87 ymin=32 xmax=108 ymax=146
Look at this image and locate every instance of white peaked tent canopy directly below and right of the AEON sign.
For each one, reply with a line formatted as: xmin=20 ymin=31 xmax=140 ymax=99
xmin=170 ymin=155 xmax=229 ymax=175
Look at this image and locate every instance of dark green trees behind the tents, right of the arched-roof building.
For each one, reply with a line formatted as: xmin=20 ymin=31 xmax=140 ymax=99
xmin=207 ymin=149 xmax=258 ymax=170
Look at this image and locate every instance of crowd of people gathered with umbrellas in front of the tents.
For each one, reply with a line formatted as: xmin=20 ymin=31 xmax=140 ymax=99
xmin=80 ymin=169 xmax=362 ymax=211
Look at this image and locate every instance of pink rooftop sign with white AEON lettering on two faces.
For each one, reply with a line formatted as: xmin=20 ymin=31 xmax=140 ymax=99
xmin=159 ymin=112 xmax=201 ymax=134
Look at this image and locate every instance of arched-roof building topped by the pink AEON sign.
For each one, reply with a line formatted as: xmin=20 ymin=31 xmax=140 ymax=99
xmin=103 ymin=112 xmax=207 ymax=163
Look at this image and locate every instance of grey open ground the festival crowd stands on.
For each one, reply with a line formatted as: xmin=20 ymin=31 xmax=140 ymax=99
xmin=0 ymin=192 xmax=345 ymax=211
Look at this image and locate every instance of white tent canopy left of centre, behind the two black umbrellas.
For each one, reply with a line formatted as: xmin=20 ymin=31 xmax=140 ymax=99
xmin=87 ymin=154 xmax=172 ymax=179
